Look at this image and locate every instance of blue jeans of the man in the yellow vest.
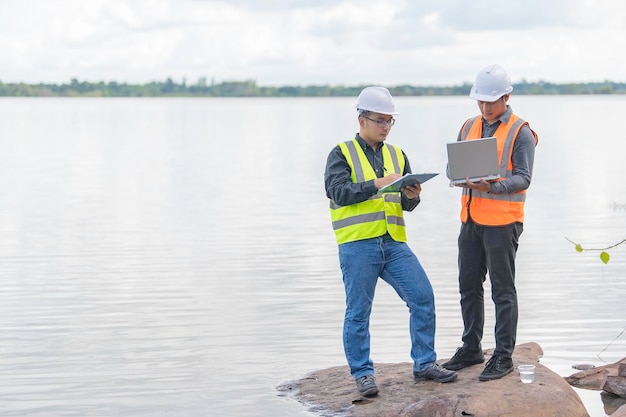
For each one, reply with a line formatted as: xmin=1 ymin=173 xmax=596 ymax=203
xmin=339 ymin=235 xmax=437 ymax=378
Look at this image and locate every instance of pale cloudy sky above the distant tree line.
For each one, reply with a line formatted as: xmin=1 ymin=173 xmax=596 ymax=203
xmin=0 ymin=0 xmax=626 ymax=86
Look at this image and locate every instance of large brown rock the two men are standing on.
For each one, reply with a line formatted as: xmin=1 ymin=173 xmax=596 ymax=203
xmin=278 ymin=343 xmax=589 ymax=417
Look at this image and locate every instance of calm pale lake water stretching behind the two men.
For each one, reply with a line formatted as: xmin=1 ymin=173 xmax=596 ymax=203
xmin=0 ymin=96 xmax=626 ymax=417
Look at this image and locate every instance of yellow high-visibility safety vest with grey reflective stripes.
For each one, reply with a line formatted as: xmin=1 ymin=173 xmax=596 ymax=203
xmin=330 ymin=139 xmax=406 ymax=244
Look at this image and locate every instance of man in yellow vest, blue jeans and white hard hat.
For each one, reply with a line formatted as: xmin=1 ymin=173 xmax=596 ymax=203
xmin=324 ymin=87 xmax=456 ymax=397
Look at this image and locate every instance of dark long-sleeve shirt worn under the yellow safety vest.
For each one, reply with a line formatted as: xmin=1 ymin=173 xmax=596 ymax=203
xmin=324 ymin=133 xmax=420 ymax=211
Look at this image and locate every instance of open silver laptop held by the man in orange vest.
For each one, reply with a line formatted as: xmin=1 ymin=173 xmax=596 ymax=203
xmin=447 ymin=137 xmax=500 ymax=186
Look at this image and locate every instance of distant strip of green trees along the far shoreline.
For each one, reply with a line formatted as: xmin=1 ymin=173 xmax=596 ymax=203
xmin=0 ymin=77 xmax=626 ymax=97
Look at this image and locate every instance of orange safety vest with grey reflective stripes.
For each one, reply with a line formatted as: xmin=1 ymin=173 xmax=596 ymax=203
xmin=460 ymin=114 xmax=538 ymax=226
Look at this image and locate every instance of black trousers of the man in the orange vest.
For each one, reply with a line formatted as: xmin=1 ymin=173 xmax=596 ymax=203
xmin=458 ymin=220 xmax=524 ymax=357
